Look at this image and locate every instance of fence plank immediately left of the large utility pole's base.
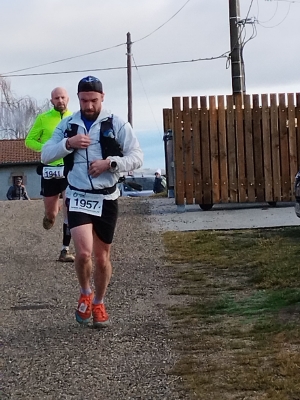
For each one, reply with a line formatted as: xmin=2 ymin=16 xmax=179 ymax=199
xmin=226 ymin=96 xmax=238 ymax=203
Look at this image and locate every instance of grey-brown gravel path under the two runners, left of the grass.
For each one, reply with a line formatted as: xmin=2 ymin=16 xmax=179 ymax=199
xmin=0 ymin=198 xmax=190 ymax=400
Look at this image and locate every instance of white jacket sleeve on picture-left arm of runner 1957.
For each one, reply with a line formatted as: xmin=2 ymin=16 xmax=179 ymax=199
xmin=41 ymin=118 xmax=74 ymax=164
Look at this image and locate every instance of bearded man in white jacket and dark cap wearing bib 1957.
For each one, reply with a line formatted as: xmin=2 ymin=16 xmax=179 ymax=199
xmin=42 ymin=76 xmax=143 ymax=328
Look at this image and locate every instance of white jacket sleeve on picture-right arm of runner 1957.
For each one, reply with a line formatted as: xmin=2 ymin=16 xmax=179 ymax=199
xmin=108 ymin=116 xmax=144 ymax=172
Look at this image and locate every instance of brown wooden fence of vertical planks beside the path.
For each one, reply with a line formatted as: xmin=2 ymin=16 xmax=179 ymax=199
xmin=163 ymin=93 xmax=300 ymax=208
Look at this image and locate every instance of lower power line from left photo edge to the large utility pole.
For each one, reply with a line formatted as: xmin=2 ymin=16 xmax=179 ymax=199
xmin=0 ymin=51 xmax=229 ymax=78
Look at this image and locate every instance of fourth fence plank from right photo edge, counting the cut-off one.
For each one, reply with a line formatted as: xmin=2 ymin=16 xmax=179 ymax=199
xmin=270 ymin=93 xmax=282 ymax=201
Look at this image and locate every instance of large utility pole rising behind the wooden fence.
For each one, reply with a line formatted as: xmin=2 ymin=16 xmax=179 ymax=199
xmin=229 ymin=0 xmax=246 ymax=94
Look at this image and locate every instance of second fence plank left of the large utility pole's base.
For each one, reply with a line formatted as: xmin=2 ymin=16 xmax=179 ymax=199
xmin=218 ymin=96 xmax=228 ymax=203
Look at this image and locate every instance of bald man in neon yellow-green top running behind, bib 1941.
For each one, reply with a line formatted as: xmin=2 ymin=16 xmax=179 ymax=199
xmin=25 ymin=87 xmax=75 ymax=262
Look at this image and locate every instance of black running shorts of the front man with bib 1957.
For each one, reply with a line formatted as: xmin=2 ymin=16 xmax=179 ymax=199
xmin=67 ymin=199 xmax=118 ymax=244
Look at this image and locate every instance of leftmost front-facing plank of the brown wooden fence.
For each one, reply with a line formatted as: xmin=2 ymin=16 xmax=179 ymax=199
xmin=172 ymin=97 xmax=185 ymax=205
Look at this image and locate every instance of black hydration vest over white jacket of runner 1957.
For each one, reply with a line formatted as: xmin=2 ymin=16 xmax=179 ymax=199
xmin=64 ymin=117 xmax=123 ymax=174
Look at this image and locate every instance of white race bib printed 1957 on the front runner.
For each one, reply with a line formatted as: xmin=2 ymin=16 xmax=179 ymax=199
xmin=69 ymin=190 xmax=103 ymax=217
